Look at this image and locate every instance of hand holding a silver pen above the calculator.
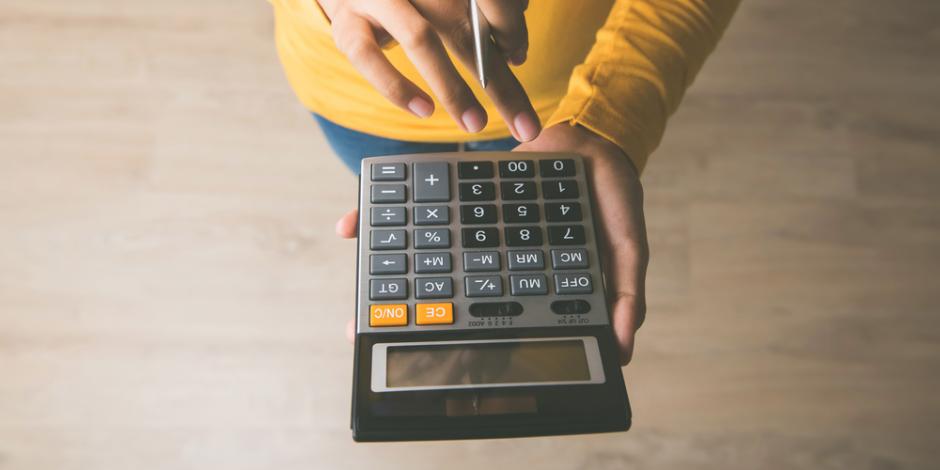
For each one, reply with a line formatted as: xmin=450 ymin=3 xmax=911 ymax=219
xmin=319 ymin=0 xmax=541 ymax=142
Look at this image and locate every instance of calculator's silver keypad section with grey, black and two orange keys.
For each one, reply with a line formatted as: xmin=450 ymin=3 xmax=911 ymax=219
xmin=358 ymin=153 xmax=609 ymax=331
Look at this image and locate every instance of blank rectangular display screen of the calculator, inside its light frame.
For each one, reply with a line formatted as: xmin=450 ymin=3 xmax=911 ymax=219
xmin=386 ymin=340 xmax=591 ymax=388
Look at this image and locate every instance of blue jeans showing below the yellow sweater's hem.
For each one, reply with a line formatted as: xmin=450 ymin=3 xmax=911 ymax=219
xmin=313 ymin=114 xmax=519 ymax=175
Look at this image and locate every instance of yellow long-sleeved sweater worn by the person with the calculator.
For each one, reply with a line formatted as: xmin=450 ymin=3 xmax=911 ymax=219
xmin=271 ymin=0 xmax=740 ymax=170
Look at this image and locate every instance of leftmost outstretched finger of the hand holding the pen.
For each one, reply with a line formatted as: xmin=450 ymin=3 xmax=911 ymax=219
xmin=333 ymin=15 xmax=434 ymax=118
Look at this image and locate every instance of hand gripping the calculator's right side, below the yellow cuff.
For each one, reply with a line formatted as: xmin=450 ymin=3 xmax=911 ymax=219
xmin=515 ymin=124 xmax=649 ymax=364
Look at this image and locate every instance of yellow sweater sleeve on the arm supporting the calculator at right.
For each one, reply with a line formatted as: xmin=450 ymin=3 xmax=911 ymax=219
xmin=546 ymin=0 xmax=740 ymax=171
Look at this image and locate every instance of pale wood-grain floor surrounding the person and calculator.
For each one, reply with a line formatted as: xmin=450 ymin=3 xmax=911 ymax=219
xmin=0 ymin=0 xmax=940 ymax=470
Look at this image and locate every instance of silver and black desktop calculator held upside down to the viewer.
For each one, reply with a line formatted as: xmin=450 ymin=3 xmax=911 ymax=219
xmin=351 ymin=152 xmax=631 ymax=441
